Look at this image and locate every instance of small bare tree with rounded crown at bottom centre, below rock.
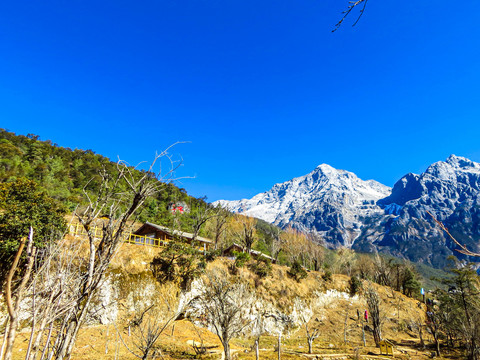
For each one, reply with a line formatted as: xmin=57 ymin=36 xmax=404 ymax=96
xmin=197 ymin=270 xmax=253 ymax=360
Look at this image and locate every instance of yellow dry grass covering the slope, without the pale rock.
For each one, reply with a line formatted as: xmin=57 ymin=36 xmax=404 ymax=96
xmin=8 ymin=238 xmax=464 ymax=360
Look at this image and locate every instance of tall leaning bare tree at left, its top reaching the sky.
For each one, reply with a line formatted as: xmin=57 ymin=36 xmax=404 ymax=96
xmin=48 ymin=147 xmax=179 ymax=360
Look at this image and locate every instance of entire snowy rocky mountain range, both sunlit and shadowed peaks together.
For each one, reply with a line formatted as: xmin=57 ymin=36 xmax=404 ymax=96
xmin=219 ymin=155 xmax=480 ymax=267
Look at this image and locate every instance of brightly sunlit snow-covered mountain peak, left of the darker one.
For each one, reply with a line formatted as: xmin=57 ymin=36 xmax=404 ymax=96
xmin=217 ymin=164 xmax=391 ymax=246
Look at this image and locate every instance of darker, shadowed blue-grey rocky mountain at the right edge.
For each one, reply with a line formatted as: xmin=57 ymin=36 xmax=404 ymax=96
xmin=353 ymin=155 xmax=480 ymax=267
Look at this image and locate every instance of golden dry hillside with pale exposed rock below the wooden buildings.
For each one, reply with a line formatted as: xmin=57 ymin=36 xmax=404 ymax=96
xmin=5 ymin=244 xmax=452 ymax=360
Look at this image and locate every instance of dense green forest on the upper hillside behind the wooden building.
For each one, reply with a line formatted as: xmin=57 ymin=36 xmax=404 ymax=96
xmin=0 ymin=129 xmax=212 ymax=230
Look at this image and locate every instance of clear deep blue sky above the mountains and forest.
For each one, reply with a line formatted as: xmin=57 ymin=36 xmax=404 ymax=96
xmin=0 ymin=0 xmax=480 ymax=201
